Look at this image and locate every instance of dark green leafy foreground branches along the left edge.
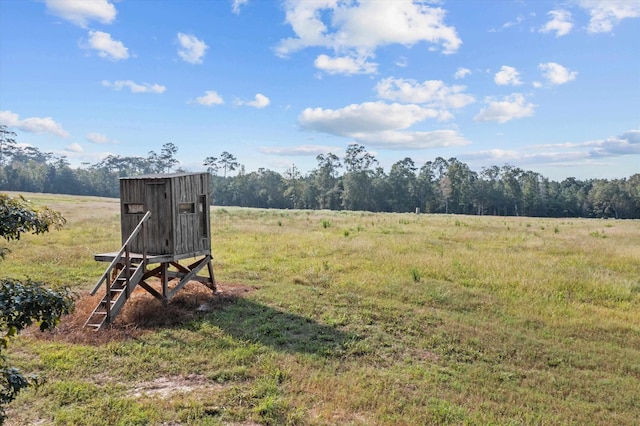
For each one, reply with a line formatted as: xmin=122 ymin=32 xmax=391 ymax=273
xmin=0 ymin=194 xmax=73 ymax=424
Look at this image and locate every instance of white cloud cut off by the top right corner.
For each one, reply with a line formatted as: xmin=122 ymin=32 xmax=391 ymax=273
xmin=577 ymin=0 xmax=640 ymax=33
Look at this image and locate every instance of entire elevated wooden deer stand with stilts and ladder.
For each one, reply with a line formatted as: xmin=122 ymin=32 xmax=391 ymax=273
xmin=85 ymin=173 xmax=216 ymax=330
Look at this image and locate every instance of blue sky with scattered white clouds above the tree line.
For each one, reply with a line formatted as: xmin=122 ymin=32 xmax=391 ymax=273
xmin=0 ymin=0 xmax=640 ymax=180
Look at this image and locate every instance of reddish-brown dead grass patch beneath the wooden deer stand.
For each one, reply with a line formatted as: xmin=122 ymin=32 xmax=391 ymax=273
xmin=24 ymin=281 xmax=255 ymax=345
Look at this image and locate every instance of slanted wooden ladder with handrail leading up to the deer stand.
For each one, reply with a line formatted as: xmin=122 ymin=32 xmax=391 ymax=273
xmin=84 ymin=212 xmax=151 ymax=330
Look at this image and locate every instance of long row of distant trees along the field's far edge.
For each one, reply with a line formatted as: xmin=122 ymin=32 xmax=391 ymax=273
xmin=0 ymin=126 xmax=640 ymax=219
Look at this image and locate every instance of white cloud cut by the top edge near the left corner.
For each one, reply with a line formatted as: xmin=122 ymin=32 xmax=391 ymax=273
xmin=45 ymin=0 xmax=117 ymax=28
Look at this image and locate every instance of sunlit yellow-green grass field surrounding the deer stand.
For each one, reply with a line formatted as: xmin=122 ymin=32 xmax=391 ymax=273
xmin=0 ymin=194 xmax=640 ymax=425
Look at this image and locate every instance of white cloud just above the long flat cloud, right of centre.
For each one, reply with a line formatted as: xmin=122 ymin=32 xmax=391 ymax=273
xmin=376 ymin=77 xmax=475 ymax=108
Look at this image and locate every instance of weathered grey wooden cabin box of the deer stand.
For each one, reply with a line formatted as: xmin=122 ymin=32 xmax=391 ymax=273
xmin=120 ymin=173 xmax=211 ymax=255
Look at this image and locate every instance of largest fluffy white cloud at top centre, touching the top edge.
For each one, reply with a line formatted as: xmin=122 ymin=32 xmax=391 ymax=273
xmin=276 ymin=0 xmax=462 ymax=73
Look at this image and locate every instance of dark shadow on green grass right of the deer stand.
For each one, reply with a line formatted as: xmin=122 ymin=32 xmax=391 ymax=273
xmin=200 ymin=298 xmax=354 ymax=357
